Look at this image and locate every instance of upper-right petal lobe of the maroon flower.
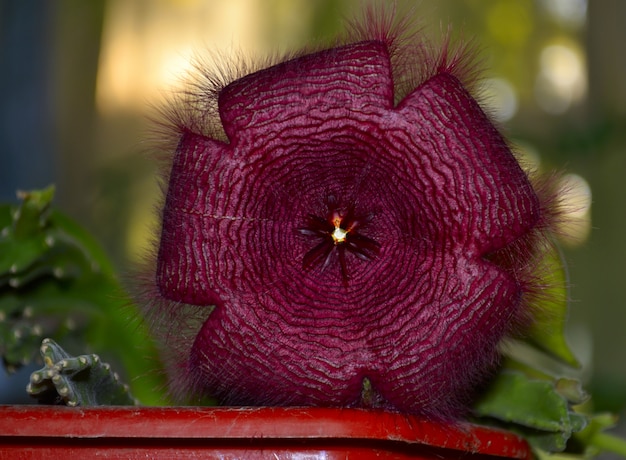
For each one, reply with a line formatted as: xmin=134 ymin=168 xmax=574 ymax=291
xmin=398 ymin=73 xmax=540 ymax=256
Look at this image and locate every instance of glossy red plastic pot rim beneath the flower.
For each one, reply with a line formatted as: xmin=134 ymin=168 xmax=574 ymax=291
xmin=0 ymin=406 xmax=532 ymax=459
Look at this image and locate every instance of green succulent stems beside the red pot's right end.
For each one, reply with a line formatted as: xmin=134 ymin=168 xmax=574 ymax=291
xmin=473 ymin=368 xmax=626 ymax=460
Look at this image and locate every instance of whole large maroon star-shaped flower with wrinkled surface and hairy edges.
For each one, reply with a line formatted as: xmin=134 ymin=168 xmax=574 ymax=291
xmin=145 ymin=17 xmax=556 ymax=417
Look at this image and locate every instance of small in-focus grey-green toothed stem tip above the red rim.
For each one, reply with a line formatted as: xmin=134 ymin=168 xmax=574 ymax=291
xmin=27 ymin=339 xmax=137 ymax=406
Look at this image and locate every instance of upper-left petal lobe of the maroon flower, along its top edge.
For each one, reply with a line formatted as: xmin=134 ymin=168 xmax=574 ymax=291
xmin=219 ymin=41 xmax=393 ymax=142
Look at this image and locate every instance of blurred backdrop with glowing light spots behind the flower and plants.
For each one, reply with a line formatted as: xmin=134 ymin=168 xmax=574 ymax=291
xmin=0 ymin=0 xmax=626 ymax=411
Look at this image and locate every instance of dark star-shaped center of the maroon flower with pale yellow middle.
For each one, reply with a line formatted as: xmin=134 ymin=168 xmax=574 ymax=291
xmin=298 ymin=196 xmax=380 ymax=284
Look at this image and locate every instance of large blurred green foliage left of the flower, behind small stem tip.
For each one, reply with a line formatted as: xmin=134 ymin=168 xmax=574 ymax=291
xmin=0 ymin=187 xmax=163 ymax=404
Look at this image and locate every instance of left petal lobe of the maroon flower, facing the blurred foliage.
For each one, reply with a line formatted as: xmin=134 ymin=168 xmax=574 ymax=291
xmin=157 ymin=133 xmax=233 ymax=305
